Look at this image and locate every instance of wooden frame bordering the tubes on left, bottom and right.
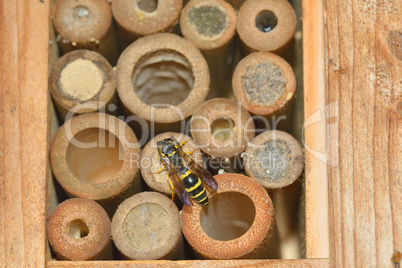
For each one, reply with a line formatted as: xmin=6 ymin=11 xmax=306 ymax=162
xmin=0 ymin=0 xmax=364 ymax=267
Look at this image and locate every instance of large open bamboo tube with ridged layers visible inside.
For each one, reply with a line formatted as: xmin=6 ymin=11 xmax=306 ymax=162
xmin=117 ymin=33 xmax=209 ymax=140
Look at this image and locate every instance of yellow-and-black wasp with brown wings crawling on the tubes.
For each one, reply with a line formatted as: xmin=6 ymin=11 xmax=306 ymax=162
xmin=157 ymin=137 xmax=218 ymax=206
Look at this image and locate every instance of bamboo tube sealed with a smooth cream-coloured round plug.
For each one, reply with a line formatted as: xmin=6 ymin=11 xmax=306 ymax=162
xmin=49 ymin=50 xmax=117 ymax=122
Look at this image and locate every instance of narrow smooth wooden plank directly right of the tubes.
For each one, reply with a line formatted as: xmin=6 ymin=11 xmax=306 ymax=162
xmin=302 ymin=0 xmax=329 ymax=258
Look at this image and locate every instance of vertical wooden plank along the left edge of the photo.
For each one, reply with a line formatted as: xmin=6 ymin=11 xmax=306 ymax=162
xmin=0 ymin=0 xmax=49 ymax=267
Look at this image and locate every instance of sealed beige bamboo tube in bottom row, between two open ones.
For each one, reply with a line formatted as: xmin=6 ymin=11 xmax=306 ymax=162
xmin=112 ymin=192 xmax=183 ymax=260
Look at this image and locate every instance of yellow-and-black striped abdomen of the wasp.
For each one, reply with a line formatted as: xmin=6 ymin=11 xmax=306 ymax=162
xmin=181 ymin=169 xmax=208 ymax=206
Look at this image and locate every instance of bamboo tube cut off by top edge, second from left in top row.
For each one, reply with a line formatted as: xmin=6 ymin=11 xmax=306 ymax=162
xmin=112 ymin=0 xmax=183 ymax=47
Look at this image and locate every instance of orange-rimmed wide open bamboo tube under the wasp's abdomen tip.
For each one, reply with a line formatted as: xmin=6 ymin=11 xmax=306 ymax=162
xmin=181 ymin=173 xmax=279 ymax=259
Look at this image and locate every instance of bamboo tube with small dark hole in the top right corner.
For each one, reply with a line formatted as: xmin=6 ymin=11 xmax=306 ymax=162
xmin=237 ymin=0 xmax=296 ymax=55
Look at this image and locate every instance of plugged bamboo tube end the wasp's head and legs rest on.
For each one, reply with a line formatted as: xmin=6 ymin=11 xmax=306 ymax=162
xmin=140 ymin=132 xmax=203 ymax=203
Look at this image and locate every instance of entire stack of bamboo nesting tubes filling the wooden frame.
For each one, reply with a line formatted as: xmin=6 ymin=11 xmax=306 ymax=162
xmin=47 ymin=0 xmax=304 ymax=260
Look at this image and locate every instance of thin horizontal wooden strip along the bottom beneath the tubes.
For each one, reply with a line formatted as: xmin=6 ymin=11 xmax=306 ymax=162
xmin=47 ymin=259 xmax=329 ymax=268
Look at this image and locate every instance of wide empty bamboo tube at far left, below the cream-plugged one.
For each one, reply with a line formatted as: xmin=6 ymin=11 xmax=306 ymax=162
xmin=50 ymin=113 xmax=141 ymax=215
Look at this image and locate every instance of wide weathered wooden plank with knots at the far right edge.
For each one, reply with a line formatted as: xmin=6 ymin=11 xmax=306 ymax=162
xmin=325 ymin=0 xmax=402 ymax=267
